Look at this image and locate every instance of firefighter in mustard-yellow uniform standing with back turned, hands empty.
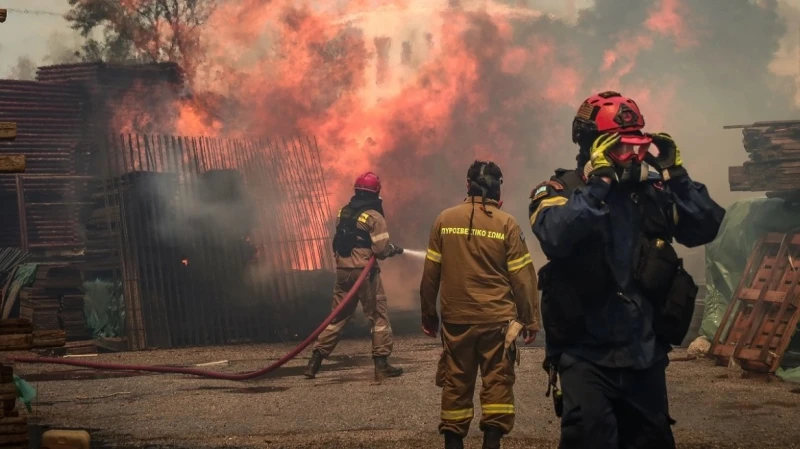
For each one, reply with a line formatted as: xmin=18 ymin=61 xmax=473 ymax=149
xmin=420 ymin=161 xmax=539 ymax=449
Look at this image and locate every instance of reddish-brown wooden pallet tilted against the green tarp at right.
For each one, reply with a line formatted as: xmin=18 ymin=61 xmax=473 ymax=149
xmin=711 ymin=233 xmax=800 ymax=373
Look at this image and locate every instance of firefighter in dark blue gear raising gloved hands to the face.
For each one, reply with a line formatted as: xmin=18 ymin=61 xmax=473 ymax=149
xmin=529 ymin=92 xmax=725 ymax=449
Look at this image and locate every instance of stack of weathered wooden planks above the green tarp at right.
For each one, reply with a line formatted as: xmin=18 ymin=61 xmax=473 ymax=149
xmin=725 ymin=120 xmax=800 ymax=192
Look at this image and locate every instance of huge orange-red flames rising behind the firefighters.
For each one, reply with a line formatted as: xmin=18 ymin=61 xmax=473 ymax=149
xmin=104 ymin=0 xmax=800 ymax=298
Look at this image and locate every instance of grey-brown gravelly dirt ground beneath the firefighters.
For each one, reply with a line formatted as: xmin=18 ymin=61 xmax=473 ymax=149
xmin=9 ymin=336 xmax=800 ymax=449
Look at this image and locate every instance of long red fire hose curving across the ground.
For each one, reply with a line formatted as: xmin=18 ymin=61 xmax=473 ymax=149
xmin=7 ymin=256 xmax=375 ymax=380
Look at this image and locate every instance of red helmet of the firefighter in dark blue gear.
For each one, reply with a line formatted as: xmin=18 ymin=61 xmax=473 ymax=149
xmin=572 ymin=91 xmax=644 ymax=143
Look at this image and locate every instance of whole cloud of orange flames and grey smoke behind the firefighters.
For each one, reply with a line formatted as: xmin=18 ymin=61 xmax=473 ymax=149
xmin=108 ymin=0 xmax=800 ymax=308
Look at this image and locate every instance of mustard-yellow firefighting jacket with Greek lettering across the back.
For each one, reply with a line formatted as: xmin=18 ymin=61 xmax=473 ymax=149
xmin=420 ymin=197 xmax=539 ymax=331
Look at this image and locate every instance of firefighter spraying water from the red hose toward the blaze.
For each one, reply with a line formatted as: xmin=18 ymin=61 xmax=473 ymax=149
xmin=305 ymin=172 xmax=403 ymax=381
